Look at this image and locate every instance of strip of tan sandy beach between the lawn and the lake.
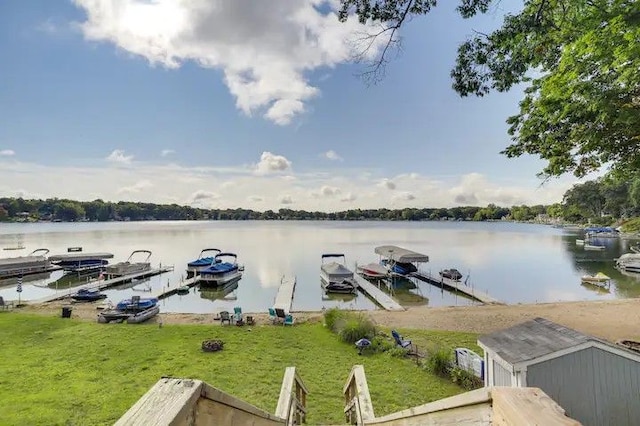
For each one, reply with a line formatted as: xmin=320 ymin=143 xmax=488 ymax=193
xmin=22 ymin=299 xmax=640 ymax=342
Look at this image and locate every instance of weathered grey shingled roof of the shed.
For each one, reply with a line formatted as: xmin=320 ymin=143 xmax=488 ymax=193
xmin=478 ymin=318 xmax=611 ymax=365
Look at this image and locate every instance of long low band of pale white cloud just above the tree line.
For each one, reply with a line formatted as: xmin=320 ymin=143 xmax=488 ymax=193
xmin=0 ymin=157 xmax=575 ymax=211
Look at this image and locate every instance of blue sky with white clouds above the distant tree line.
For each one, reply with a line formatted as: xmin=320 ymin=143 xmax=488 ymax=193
xmin=0 ymin=0 xmax=572 ymax=210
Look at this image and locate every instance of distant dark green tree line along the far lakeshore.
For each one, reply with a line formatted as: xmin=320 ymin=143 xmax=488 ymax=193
xmin=0 ymin=174 xmax=640 ymax=225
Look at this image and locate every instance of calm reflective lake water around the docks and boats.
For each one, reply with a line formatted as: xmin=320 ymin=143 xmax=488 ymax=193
xmin=0 ymin=221 xmax=640 ymax=313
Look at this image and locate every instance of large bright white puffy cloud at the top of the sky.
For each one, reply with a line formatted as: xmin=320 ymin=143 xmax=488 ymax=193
xmin=74 ymin=0 xmax=384 ymax=125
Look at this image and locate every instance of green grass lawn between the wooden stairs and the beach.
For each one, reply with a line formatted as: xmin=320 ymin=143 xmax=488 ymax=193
xmin=0 ymin=312 xmax=477 ymax=425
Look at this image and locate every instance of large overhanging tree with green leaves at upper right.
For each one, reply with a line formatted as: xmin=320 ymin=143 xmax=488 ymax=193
xmin=339 ymin=0 xmax=640 ymax=177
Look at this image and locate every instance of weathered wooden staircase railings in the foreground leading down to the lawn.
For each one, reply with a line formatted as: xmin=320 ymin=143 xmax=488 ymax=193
xmin=115 ymin=365 xmax=580 ymax=426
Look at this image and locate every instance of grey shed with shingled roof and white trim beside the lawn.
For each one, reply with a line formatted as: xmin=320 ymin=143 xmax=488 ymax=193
xmin=478 ymin=318 xmax=640 ymax=426
